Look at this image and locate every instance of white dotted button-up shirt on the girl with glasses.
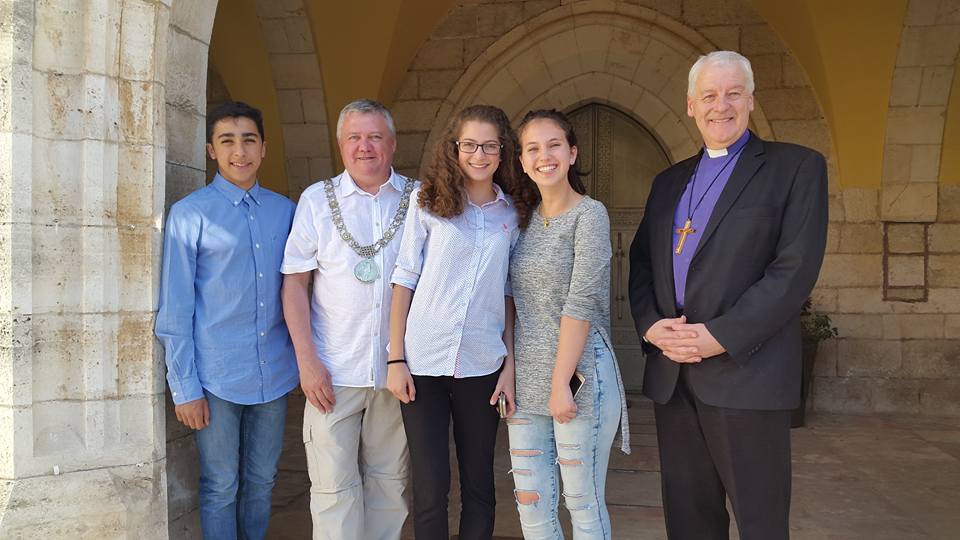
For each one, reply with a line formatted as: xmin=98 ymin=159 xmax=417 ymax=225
xmin=391 ymin=184 xmax=519 ymax=378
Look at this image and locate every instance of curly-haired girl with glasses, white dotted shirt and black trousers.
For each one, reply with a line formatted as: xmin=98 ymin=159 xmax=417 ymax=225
xmin=387 ymin=105 xmax=529 ymax=540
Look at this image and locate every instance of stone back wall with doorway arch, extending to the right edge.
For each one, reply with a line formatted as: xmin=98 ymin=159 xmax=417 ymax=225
xmin=394 ymin=0 xmax=960 ymax=415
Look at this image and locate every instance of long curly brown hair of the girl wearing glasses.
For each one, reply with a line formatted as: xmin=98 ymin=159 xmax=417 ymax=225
xmin=417 ymin=105 xmax=531 ymax=221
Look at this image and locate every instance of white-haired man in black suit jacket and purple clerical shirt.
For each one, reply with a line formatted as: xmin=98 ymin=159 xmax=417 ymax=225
xmin=630 ymin=51 xmax=827 ymax=540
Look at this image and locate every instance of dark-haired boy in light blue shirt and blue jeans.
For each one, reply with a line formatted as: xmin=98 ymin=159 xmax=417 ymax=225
xmin=156 ymin=102 xmax=298 ymax=539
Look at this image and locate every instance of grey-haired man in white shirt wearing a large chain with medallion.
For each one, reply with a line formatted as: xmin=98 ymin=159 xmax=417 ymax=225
xmin=281 ymin=100 xmax=415 ymax=540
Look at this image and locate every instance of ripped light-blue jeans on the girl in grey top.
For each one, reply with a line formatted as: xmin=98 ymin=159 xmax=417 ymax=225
xmin=507 ymin=334 xmax=620 ymax=540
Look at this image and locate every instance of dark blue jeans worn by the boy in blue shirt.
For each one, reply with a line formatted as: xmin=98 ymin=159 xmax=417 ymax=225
xmin=196 ymin=391 xmax=287 ymax=540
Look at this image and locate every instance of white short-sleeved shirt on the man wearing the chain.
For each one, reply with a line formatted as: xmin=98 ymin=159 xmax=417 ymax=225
xmin=280 ymin=170 xmax=413 ymax=388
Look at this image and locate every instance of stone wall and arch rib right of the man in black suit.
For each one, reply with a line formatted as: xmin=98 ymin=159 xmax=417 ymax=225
xmin=814 ymin=0 xmax=960 ymax=416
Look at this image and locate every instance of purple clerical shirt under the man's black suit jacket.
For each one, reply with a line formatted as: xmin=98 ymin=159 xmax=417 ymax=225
xmin=673 ymin=131 xmax=750 ymax=309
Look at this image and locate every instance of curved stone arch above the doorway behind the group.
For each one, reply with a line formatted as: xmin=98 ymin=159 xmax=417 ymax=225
xmin=421 ymin=2 xmax=770 ymax=167
